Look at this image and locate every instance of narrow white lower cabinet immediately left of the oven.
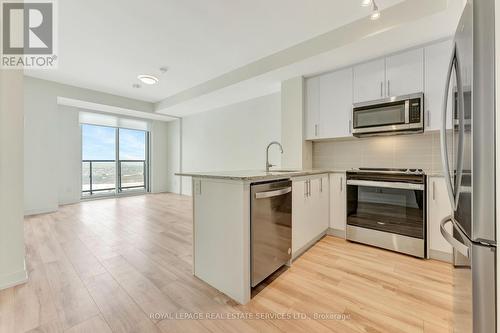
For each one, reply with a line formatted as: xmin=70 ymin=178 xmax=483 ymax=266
xmin=330 ymin=173 xmax=347 ymax=238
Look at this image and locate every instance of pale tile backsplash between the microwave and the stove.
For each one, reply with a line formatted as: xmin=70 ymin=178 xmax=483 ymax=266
xmin=313 ymin=132 xmax=448 ymax=173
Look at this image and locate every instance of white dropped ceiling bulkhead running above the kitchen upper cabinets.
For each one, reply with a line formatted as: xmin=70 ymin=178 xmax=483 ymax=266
xmin=156 ymin=0 xmax=465 ymax=117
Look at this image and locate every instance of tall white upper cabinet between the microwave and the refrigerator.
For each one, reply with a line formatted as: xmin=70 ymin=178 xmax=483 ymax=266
xmin=424 ymin=40 xmax=452 ymax=130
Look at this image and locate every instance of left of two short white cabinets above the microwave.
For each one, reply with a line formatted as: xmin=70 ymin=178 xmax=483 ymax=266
xmin=353 ymin=58 xmax=385 ymax=103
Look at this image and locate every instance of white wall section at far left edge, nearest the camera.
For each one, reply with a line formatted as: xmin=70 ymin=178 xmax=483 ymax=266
xmin=0 ymin=70 xmax=27 ymax=289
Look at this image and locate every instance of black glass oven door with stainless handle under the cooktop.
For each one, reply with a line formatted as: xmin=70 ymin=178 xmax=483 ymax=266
xmin=347 ymin=179 xmax=425 ymax=240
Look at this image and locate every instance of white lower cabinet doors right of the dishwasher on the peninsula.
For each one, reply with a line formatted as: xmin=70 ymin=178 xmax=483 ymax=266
xmin=292 ymin=174 xmax=329 ymax=257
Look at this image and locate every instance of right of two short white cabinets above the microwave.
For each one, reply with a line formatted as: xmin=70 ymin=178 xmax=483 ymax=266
xmin=385 ymin=49 xmax=424 ymax=97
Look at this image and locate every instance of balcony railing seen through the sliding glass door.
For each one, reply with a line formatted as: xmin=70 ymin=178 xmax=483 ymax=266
xmin=82 ymin=160 xmax=147 ymax=195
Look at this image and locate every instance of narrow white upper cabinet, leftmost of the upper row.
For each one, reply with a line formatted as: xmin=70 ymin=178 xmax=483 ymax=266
xmin=304 ymin=77 xmax=320 ymax=140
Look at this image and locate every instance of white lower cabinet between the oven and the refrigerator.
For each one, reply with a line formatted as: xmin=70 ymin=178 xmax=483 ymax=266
xmin=427 ymin=177 xmax=452 ymax=260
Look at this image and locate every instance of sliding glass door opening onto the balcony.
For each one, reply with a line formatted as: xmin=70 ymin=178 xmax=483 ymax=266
xmin=82 ymin=124 xmax=149 ymax=197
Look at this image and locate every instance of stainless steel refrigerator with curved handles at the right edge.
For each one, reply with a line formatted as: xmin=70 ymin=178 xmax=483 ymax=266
xmin=441 ymin=0 xmax=497 ymax=333
